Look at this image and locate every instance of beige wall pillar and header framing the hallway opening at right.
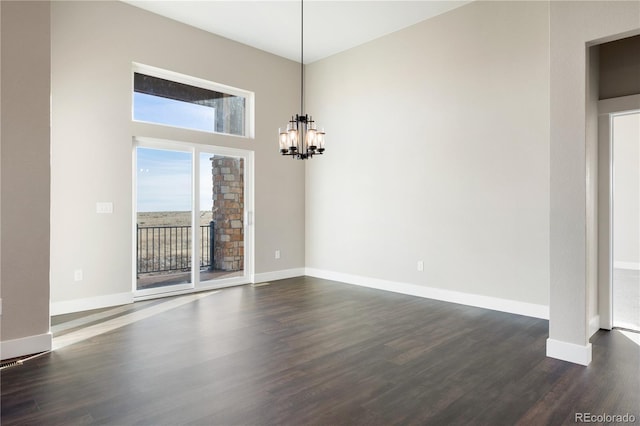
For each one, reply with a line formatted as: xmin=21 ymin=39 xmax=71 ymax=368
xmin=547 ymin=1 xmax=640 ymax=364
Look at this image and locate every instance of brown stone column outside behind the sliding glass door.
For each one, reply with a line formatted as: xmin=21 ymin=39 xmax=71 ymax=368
xmin=211 ymin=156 xmax=244 ymax=271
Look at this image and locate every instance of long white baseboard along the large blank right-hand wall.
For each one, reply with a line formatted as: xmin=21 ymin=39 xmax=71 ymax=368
xmin=305 ymin=268 xmax=549 ymax=319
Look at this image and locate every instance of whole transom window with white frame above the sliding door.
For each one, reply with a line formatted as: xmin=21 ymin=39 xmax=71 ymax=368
xmin=133 ymin=64 xmax=253 ymax=137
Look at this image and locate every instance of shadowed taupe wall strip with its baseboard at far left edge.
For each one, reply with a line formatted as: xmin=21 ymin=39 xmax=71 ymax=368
xmin=0 ymin=1 xmax=51 ymax=359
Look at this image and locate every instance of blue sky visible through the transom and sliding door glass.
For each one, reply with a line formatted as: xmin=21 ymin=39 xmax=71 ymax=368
xmin=134 ymin=92 xmax=215 ymax=212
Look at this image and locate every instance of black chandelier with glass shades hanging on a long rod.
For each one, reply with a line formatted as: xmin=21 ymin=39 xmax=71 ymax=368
xmin=278 ymin=0 xmax=324 ymax=160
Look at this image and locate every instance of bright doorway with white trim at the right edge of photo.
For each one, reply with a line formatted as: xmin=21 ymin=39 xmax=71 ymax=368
xmin=598 ymin=95 xmax=640 ymax=332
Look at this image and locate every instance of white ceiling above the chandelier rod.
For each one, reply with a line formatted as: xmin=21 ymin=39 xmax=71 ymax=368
xmin=123 ymin=0 xmax=471 ymax=63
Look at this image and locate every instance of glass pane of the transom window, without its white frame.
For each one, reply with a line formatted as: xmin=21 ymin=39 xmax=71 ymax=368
xmin=133 ymin=73 xmax=247 ymax=136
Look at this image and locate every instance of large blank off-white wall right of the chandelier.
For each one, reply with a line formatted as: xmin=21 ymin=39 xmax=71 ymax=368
xmin=306 ymin=1 xmax=550 ymax=311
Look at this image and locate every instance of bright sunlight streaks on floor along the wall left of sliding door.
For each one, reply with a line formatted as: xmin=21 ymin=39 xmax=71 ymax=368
xmin=52 ymin=290 xmax=220 ymax=350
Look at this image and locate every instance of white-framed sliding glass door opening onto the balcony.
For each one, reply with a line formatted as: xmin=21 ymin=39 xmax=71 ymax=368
xmin=134 ymin=139 xmax=253 ymax=297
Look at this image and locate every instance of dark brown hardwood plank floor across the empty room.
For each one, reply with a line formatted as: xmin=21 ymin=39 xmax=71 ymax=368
xmin=1 ymin=277 xmax=640 ymax=426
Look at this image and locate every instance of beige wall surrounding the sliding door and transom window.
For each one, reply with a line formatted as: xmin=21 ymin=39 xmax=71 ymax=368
xmin=51 ymin=1 xmax=304 ymax=309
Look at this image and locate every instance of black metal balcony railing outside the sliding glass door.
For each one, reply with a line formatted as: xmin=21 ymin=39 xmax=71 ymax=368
xmin=136 ymin=221 xmax=215 ymax=274
